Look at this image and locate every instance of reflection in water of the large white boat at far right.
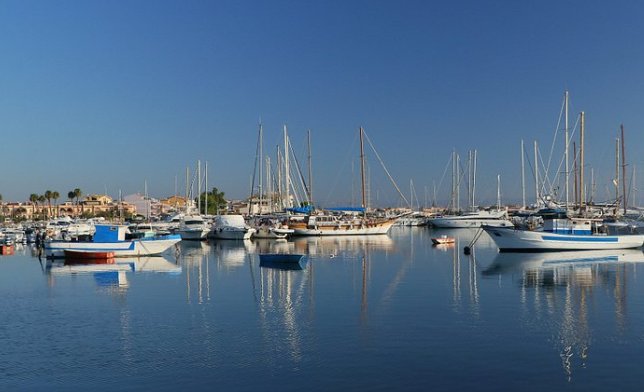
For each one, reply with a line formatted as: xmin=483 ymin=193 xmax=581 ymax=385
xmin=482 ymin=249 xmax=644 ymax=381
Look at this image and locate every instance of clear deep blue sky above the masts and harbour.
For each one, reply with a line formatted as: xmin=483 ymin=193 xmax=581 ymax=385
xmin=0 ymin=1 xmax=644 ymax=205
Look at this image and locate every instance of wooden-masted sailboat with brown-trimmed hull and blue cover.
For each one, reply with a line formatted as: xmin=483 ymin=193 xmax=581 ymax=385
xmin=288 ymin=127 xmax=398 ymax=236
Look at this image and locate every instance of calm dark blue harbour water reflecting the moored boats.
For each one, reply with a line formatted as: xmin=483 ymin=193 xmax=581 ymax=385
xmin=0 ymin=228 xmax=644 ymax=391
